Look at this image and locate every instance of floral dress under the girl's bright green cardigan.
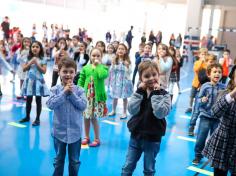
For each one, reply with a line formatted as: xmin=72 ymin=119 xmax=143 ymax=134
xmin=84 ymin=76 xmax=108 ymax=119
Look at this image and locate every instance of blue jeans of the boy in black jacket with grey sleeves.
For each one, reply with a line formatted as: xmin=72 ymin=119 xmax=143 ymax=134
xmin=121 ymin=137 xmax=160 ymax=176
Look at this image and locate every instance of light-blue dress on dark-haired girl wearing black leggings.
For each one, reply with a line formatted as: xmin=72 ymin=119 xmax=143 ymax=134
xmin=21 ymin=58 xmax=50 ymax=97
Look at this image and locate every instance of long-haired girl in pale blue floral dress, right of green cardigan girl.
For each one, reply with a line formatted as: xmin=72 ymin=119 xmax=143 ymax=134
xmin=109 ymin=43 xmax=133 ymax=119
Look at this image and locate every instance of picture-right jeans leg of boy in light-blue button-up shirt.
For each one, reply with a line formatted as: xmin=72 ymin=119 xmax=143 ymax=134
xmin=68 ymin=139 xmax=81 ymax=176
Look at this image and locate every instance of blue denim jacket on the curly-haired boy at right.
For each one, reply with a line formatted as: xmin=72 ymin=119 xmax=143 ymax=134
xmin=198 ymin=82 xmax=225 ymax=118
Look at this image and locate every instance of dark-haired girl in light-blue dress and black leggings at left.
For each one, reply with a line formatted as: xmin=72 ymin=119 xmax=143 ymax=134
xmin=19 ymin=41 xmax=49 ymax=126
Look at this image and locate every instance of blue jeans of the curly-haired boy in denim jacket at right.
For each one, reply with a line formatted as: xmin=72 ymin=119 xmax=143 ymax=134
xmin=194 ymin=116 xmax=219 ymax=158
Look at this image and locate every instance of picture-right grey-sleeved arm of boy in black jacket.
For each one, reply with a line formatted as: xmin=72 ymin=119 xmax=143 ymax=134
xmin=150 ymin=90 xmax=171 ymax=119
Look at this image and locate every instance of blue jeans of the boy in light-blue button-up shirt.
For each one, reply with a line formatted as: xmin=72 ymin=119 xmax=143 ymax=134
xmin=53 ymin=137 xmax=81 ymax=176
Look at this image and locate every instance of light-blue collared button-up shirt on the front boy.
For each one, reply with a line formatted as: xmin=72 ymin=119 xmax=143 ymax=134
xmin=46 ymin=85 xmax=87 ymax=144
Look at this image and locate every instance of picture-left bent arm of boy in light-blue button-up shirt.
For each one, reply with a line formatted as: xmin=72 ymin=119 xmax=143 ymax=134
xmin=46 ymin=87 xmax=67 ymax=110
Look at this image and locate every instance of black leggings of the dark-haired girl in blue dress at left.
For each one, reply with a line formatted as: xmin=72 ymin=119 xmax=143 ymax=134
xmin=26 ymin=96 xmax=42 ymax=120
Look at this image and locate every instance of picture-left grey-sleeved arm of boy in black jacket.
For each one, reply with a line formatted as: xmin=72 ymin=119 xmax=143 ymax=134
xmin=128 ymin=88 xmax=146 ymax=115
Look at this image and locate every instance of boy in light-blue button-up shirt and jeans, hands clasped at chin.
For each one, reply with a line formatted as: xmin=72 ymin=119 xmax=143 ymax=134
xmin=46 ymin=58 xmax=87 ymax=176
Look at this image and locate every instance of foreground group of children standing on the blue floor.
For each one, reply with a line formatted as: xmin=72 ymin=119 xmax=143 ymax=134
xmin=0 ymin=29 xmax=236 ymax=175
